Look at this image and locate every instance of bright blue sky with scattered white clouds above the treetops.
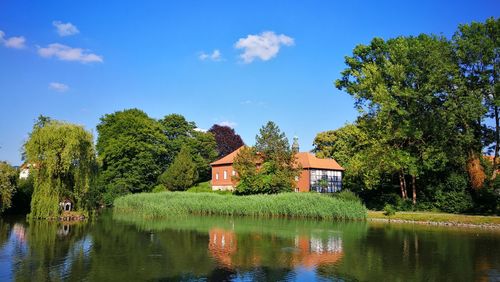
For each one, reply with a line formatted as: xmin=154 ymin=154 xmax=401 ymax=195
xmin=0 ymin=0 xmax=500 ymax=165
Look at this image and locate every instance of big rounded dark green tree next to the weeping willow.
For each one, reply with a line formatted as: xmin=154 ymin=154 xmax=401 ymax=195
xmin=96 ymin=109 xmax=168 ymax=205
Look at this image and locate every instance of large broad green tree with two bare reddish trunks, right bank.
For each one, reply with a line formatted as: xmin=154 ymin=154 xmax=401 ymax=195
xmin=336 ymin=35 xmax=484 ymax=204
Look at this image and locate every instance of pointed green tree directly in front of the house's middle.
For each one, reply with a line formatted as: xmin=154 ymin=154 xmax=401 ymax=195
xmin=233 ymin=121 xmax=300 ymax=195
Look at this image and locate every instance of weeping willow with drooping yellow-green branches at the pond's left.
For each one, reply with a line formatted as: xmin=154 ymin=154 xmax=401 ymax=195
xmin=24 ymin=120 xmax=96 ymax=218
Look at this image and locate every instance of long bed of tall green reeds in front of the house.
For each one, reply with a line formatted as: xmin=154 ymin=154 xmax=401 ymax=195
xmin=114 ymin=192 xmax=366 ymax=219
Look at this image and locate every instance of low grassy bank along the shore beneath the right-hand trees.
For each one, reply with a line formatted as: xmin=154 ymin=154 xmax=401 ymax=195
xmin=368 ymin=211 xmax=500 ymax=226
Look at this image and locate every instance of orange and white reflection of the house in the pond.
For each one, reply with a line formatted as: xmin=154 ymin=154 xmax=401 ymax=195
xmin=208 ymin=228 xmax=344 ymax=269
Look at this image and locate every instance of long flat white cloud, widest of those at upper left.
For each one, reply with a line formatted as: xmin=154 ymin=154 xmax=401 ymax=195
xmin=38 ymin=43 xmax=103 ymax=63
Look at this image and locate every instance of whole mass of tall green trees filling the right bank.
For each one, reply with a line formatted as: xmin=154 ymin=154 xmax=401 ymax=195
xmin=314 ymin=18 xmax=500 ymax=212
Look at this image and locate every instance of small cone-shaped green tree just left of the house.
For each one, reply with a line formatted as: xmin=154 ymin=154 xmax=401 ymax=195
xmin=159 ymin=146 xmax=198 ymax=191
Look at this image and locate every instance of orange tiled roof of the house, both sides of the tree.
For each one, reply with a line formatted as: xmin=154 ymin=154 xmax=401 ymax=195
xmin=210 ymin=146 xmax=344 ymax=170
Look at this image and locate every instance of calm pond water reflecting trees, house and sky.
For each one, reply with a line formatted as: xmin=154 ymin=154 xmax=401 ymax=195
xmin=0 ymin=212 xmax=500 ymax=281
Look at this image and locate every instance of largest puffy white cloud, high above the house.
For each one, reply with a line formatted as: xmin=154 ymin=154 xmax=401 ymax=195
xmin=234 ymin=31 xmax=294 ymax=64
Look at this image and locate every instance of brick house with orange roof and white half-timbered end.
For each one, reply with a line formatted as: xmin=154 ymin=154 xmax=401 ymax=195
xmin=210 ymin=144 xmax=344 ymax=193
